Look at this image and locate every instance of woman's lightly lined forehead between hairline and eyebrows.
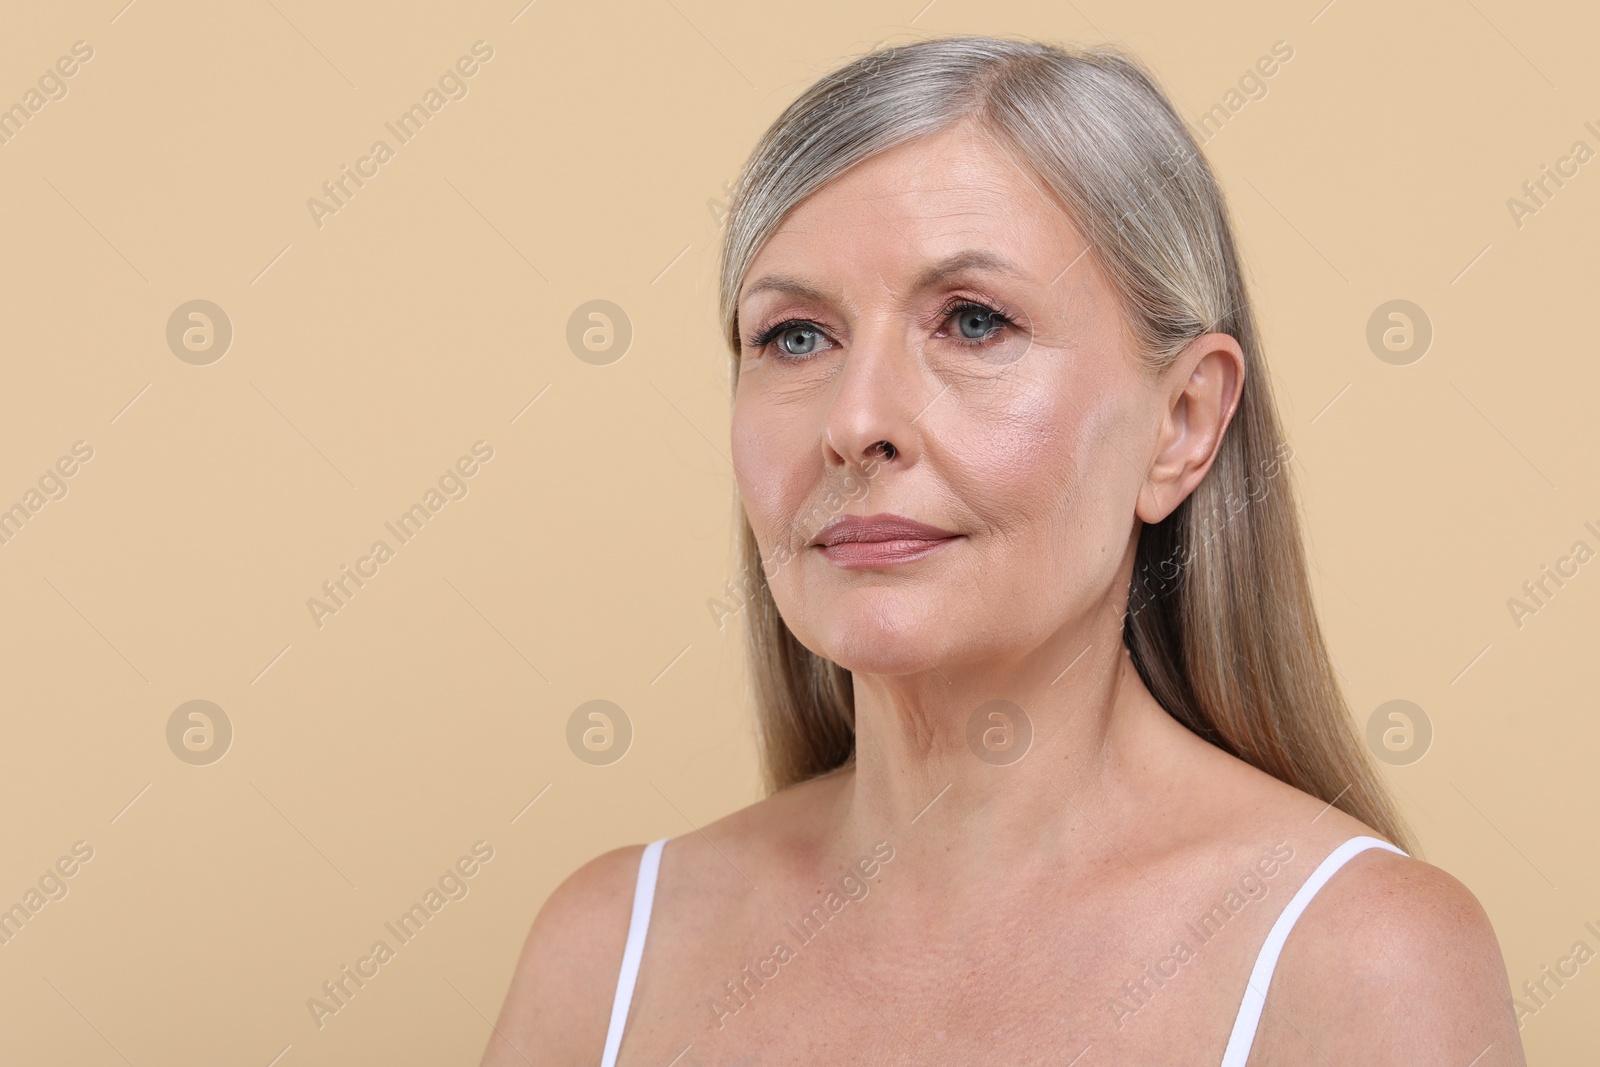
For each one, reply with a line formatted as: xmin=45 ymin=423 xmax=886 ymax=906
xmin=741 ymin=125 xmax=1085 ymax=302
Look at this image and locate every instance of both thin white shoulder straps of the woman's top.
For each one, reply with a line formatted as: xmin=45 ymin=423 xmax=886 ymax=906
xmin=600 ymin=837 xmax=1406 ymax=1067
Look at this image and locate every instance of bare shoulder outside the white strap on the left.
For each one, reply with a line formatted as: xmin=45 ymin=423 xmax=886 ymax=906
xmin=482 ymin=845 xmax=645 ymax=1067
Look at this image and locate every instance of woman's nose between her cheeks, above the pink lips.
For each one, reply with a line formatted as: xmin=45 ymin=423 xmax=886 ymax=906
xmin=822 ymin=322 xmax=925 ymax=477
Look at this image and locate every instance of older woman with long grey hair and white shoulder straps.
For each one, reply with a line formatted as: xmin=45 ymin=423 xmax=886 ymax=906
xmin=483 ymin=37 xmax=1523 ymax=1067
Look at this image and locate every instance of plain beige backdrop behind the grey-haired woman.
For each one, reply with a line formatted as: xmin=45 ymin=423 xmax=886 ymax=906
xmin=0 ymin=0 xmax=1600 ymax=1067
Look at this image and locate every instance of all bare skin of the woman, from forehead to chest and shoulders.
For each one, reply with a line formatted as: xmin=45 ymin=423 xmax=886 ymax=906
xmin=483 ymin=126 xmax=1523 ymax=1067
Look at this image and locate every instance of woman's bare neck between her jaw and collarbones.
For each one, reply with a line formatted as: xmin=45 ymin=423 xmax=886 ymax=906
xmin=834 ymin=611 xmax=1165 ymax=891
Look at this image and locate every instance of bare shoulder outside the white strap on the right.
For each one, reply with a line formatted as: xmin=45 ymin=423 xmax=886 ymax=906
xmin=1258 ymin=848 xmax=1526 ymax=1067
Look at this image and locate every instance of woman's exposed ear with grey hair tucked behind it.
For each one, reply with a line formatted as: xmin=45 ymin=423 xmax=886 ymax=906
xmin=1134 ymin=333 xmax=1245 ymax=523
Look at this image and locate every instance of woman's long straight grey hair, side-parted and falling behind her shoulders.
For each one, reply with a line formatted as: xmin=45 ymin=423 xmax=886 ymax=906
xmin=718 ymin=37 xmax=1416 ymax=854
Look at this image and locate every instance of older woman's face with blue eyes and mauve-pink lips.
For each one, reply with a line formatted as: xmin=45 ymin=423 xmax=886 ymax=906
xmin=733 ymin=126 xmax=1176 ymax=675
